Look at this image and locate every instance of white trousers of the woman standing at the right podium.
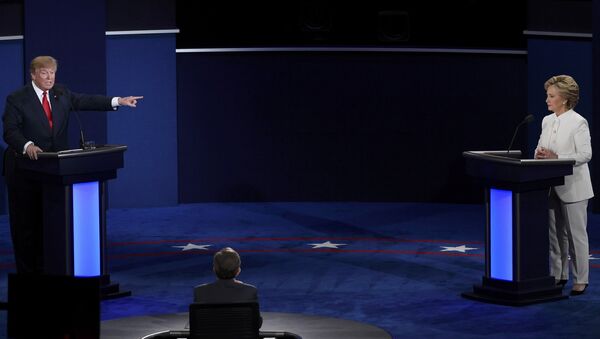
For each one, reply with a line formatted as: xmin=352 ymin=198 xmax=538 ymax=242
xmin=549 ymin=189 xmax=590 ymax=284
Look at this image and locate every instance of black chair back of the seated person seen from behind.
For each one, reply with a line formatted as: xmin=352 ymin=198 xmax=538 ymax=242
xmin=189 ymin=302 xmax=261 ymax=339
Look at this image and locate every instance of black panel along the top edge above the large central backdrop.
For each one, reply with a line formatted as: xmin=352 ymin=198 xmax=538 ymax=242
xmin=177 ymin=0 xmax=527 ymax=48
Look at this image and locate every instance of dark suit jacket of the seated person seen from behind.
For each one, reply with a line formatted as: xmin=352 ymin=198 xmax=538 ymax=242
xmin=194 ymin=279 xmax=258 ymax=304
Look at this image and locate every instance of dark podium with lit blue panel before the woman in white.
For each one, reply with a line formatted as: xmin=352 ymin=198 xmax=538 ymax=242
xmin=462 ymin=151 xmax=575 ymax=306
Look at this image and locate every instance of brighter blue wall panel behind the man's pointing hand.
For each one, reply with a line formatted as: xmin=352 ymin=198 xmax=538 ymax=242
xmin=106 ymin=34 xmax=177 ymax=207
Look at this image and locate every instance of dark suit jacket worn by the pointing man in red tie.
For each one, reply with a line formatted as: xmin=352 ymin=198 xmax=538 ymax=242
xmin=2 ymin=82 xmax=113 ymax=153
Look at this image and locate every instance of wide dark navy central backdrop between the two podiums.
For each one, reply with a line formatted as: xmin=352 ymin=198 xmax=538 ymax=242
xmin=177 ymin=52 xmax=527 ymax=202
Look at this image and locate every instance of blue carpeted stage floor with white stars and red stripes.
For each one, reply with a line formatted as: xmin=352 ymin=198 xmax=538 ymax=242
xmin=0 ymin=203 xmax=600 ymax=338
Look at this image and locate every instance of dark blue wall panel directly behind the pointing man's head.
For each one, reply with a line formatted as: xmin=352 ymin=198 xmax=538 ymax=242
xmin=24 ymin=0 xmax=106 ymax=147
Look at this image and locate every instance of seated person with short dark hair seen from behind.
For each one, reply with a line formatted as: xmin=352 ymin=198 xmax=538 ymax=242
xmin=194 ymin=247 xmax=258 ymax=304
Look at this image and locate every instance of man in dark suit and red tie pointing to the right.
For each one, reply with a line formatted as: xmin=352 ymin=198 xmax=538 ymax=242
xmin=2 ymin=56 xmax=142 ymax=273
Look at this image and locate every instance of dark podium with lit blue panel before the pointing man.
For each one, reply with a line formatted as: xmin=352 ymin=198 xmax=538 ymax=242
xmin=16 ymin=145 xmax=131 ymax=299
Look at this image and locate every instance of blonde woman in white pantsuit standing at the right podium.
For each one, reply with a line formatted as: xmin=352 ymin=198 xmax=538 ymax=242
xmin=535 ymin=75 xmax=594 ymax=295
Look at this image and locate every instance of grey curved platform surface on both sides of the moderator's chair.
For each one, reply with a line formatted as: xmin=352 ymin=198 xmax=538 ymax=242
xmin=100 ymin=312 xmax=392 ymax=339
